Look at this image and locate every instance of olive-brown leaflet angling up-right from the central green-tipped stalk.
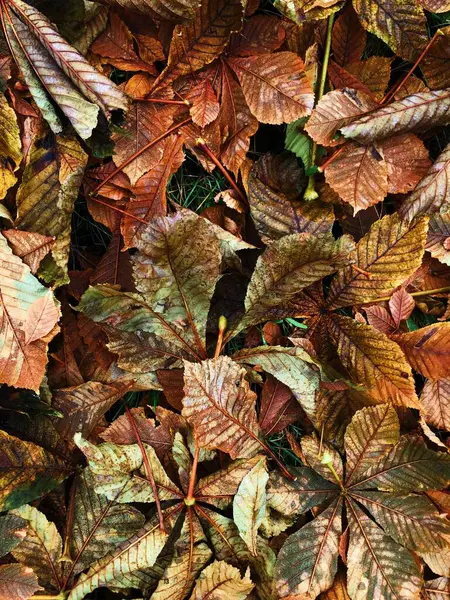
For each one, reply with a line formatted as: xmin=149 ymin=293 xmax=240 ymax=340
xmin=234 ymin=233 xmax=354 ymax=333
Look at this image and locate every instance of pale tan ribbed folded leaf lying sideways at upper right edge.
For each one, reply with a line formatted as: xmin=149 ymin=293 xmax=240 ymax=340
xmin=342 ymin=89 xmax=450 ymax=144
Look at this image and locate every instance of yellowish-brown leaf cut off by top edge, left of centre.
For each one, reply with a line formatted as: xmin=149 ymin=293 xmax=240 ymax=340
xmin=90 ymin=0 xmax=198 ymax=22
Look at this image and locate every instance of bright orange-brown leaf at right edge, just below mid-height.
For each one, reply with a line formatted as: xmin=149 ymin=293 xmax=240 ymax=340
xmin=392 ymin=323 xmax=450 ymax=379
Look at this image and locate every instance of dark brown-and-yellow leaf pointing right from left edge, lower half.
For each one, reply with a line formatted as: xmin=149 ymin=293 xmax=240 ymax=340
xmin=0 ymin=431 xmax=72 ymax=511
